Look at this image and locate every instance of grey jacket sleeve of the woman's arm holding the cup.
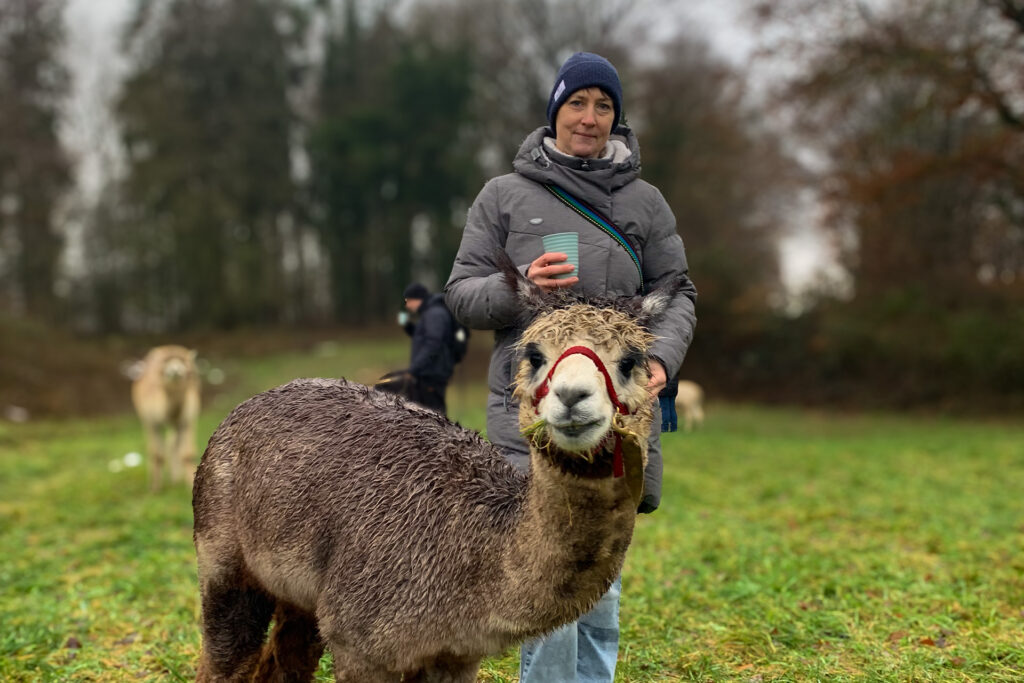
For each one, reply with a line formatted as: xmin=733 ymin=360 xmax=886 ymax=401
xmin=444 ymin=178 xmax=529 ymax=330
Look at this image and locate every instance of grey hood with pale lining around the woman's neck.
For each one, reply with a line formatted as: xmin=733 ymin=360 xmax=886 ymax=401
xmin=512 ymin=126 xmax=640 ymax=205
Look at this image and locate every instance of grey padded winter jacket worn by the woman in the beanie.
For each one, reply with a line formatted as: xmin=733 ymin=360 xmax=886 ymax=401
xmin=444 ymin=126 xmax=696 ymax=512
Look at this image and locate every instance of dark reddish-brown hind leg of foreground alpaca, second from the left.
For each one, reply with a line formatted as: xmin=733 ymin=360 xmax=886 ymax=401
xmin=253 ymin=604 xmax=324 ymax=683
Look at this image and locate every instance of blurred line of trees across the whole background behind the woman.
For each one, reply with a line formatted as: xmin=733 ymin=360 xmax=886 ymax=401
xmin=0 ymin=0 xmax=1024 ymax=404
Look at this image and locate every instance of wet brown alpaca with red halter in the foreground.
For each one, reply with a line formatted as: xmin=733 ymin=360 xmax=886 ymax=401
xmin=193 ymin=263 xmax=675 ymax=683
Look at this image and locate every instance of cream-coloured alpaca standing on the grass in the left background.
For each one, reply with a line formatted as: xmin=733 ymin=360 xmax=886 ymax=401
xmin=131 ymin=346 xmax=200 ymax=490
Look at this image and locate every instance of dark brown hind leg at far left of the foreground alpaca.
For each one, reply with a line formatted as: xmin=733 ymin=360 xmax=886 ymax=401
xmin=196 ymin=577 xmax=273 ymax=683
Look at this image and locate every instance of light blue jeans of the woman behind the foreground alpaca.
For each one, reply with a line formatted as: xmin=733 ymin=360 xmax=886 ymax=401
xmin=519 ymin=577 xmax=623 ymax=683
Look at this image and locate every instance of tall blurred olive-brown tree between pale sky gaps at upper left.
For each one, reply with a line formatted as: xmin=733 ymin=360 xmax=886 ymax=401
xmin=107 ymin=0 xmax=301 ymax=328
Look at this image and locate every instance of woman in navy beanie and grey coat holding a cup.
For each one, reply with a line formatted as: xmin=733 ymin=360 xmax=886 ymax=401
xmin=444 ymin=52 xmax=696 ymax=683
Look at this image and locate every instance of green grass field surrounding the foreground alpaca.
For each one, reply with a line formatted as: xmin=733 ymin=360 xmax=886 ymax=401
xmin=0 ymin=340 xmax=1024 ymax=683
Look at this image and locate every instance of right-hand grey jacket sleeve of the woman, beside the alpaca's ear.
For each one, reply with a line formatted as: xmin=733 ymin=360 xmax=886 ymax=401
xmin=643 ymin=189 xmax=697 ymax=378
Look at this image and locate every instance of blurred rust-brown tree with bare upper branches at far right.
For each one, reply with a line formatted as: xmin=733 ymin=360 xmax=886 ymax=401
xmin=762 ymin=0 xmax=1024 ymax=302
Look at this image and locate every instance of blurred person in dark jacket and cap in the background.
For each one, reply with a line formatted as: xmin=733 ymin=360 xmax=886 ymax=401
xmin=402 ymin=283 xmax=455 ymax=415
